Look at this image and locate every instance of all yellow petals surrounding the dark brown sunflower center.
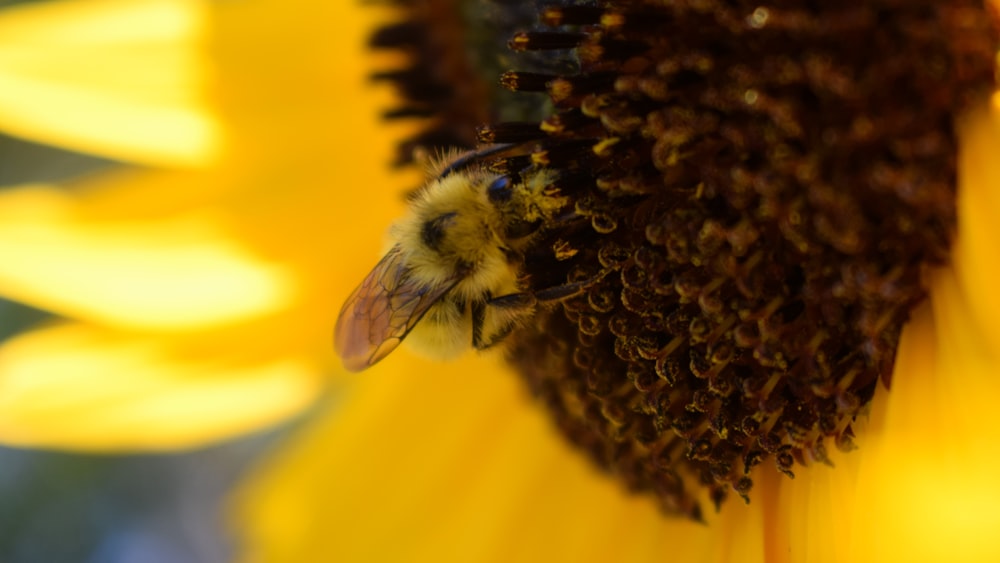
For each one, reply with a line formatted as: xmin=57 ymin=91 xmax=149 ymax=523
xmin=0 ymin=1 xmax=1000 ymax=561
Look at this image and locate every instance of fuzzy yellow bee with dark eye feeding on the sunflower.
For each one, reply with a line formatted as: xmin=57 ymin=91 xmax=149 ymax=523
xmin=334 ymin=147 xmax=583 ymax=371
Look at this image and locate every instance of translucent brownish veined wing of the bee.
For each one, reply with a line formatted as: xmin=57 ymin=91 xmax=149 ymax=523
xmin=334 ymin=246 xmax=459 ymax=371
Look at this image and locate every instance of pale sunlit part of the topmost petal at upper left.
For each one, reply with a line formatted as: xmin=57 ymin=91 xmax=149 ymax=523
xmin=0 ymin=0 xmax=222 ymax=166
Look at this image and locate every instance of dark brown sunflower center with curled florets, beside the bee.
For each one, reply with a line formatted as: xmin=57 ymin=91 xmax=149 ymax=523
xmin=376 ymin=0 xmax=997 ymax=519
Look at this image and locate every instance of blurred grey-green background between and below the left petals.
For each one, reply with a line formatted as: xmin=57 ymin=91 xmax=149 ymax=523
xmin=0 ymin=129 xmax=283 ymax=563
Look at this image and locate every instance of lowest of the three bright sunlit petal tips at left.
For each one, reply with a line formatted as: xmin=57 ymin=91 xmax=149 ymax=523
xmin=0 ymin=325 xmax=320 ymax=451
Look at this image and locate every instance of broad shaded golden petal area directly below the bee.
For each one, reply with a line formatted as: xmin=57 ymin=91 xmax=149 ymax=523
xmin=236 ymin=352 xmax=763 ymax=562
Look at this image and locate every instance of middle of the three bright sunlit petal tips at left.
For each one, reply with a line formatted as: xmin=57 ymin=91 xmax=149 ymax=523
xmin=0 ymin=177 xmax=296 ymax=329
